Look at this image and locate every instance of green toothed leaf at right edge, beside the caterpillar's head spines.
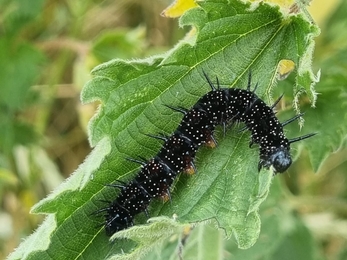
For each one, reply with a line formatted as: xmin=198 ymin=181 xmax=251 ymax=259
xmin=287 ymin=49 xmax=347 ymax=172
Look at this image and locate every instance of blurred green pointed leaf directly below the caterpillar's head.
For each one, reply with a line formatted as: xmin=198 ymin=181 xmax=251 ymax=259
xmin=225 ymin=179 xmax=322 ymax=260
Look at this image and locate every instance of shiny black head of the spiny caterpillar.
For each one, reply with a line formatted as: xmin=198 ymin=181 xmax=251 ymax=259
xmin=258 ymin=146 xmax=292 ymax=173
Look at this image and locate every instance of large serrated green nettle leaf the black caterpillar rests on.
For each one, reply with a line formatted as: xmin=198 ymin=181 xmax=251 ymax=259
xmin=10 ymin=0 xmax=318 ymax=259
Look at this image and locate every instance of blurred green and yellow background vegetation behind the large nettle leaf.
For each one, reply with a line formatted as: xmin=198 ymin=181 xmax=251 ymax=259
xmin=0 ymin=0 xmax=347 ymax=259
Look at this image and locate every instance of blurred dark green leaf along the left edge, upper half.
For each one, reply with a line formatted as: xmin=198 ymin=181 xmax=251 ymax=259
xmin=0 ymin=5 xmax=44 ymax=155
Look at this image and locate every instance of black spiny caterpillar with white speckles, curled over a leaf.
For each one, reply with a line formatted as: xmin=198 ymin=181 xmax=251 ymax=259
xmin=95 ymin=73 xmax=315 ymax=236
